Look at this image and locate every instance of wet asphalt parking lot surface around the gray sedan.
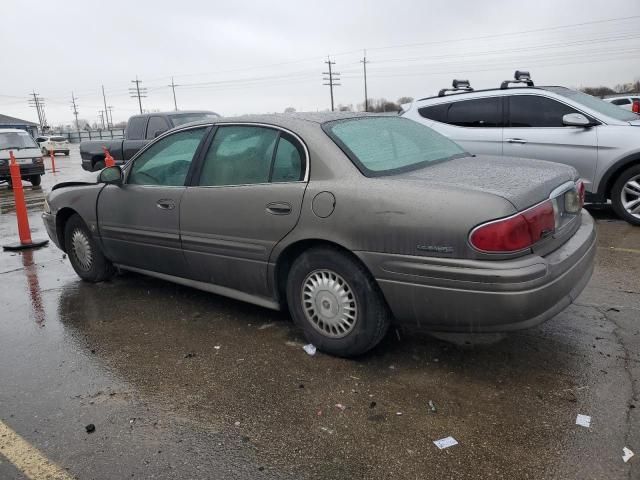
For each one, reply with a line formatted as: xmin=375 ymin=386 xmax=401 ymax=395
xmin=0 ymin=149 xmax=640 ymax=480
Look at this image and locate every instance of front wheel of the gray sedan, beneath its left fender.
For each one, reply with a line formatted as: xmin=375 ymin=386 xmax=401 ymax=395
xmin=64 ymin=214 xmax=116 ymax=283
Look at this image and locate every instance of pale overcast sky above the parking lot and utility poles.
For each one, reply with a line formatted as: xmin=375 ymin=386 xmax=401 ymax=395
xmin=0 ymin=0 xmax=640 ymax=125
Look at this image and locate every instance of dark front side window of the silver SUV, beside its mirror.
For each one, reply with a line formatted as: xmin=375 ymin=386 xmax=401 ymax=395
xmin=507 ymin=95 xmax=579 ymax=128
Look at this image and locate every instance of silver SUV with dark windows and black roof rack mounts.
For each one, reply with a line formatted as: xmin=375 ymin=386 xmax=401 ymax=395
xmin=401 ymin=72 xmax=640 ymax=225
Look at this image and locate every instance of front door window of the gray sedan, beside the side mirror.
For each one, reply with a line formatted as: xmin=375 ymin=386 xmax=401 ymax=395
xmin=127 ymin=127 xmax=206 ymax=187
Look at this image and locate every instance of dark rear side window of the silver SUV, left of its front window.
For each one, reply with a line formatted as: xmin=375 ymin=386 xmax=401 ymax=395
xmin=418 ymin=97 xmax=502 ymax=128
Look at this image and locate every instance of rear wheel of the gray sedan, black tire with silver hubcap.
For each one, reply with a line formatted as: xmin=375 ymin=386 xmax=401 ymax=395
xmin=287 ymin=247 xmax=391 ymax=357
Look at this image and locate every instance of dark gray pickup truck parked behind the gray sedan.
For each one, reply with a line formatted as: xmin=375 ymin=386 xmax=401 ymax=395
xmin=80 ymin=110 xmax=220 ymax=172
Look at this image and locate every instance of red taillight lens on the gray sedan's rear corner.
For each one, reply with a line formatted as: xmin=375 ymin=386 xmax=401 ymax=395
xmin=469 ymin=200 xmax=555 ymax=252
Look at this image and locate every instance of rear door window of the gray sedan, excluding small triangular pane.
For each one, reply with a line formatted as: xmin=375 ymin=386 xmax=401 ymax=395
xmin=199 ymin=126 xmax=278 ymax=186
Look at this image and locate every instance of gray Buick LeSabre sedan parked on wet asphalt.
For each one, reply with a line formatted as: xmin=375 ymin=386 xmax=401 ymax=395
xmin=43 ymin=113 xmax=596 ymax=356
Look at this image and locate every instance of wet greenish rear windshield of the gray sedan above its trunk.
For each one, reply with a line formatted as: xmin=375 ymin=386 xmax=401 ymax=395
xmin=322 ymin=117 xmax=469 ymax=177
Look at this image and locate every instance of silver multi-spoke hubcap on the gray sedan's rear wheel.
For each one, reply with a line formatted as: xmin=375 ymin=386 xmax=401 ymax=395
xmin=302 ymin=270 xmax=358 ymax=338
